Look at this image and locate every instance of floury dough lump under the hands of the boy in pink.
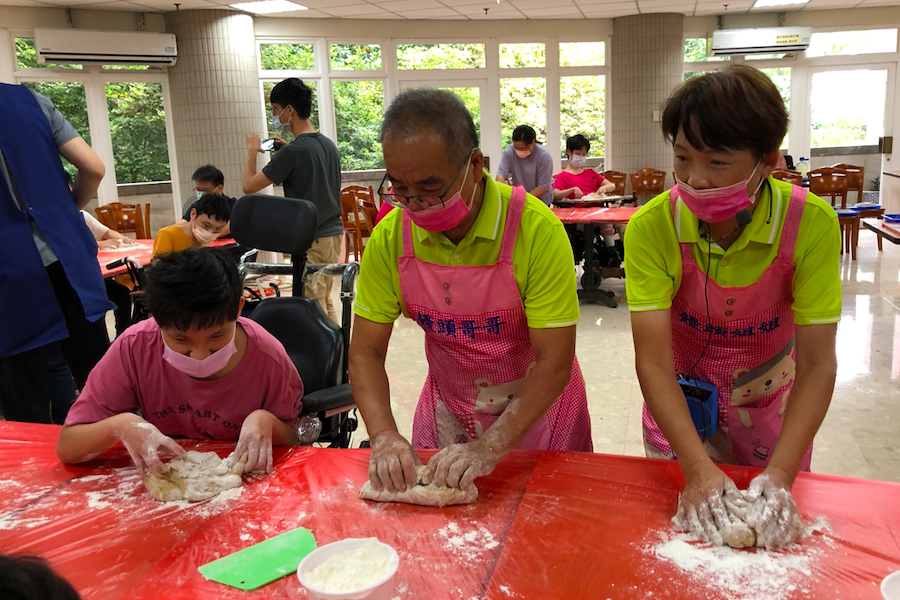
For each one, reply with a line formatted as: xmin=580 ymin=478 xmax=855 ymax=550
xmin=144 ymin=450 xmax=247 ymax=502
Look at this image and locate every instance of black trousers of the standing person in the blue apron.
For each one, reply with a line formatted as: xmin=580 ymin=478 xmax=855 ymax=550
xmin=0 ymin=262 xmax=109 ymax=423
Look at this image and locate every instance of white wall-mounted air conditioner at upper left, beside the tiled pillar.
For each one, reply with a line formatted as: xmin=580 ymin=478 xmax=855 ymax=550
xmin=34 ymin=29 xmax=178 ymax=67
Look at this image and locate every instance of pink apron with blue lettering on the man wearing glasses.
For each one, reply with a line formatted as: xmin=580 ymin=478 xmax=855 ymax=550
xmin=399 ymin=187 xmax=592 ymax=452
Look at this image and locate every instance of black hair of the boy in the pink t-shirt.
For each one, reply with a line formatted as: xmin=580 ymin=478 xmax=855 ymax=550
xmin=144 ymin=248 xmax=244 ymax=331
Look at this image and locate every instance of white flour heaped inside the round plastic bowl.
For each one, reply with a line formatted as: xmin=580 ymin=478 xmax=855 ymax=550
xmin=304 ymin=538 xmax=398 ymax=592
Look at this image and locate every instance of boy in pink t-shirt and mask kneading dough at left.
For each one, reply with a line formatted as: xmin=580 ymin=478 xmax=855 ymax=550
xmin=56 ymin=248 xmax=303 ymax=475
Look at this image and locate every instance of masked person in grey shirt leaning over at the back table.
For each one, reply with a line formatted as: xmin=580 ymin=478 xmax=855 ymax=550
xmin=497 ymin=125 xmax=553 ymax=206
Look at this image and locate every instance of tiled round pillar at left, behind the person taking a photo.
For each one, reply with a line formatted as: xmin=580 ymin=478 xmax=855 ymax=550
xmin=166 ymin=10 xmax=264 ymax=214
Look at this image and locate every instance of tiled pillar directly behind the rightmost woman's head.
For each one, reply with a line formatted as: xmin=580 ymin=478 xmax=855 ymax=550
xmin=609 ymin=14 xmax=684 ymax=182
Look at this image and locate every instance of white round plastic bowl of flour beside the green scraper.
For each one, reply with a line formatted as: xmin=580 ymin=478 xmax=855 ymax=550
xmin=297 ymin=538 xmax=400 ymax=600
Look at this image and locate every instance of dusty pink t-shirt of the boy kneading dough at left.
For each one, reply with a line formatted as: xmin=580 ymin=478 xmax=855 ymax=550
xmin=66 ymin=317 xmax=303 ymax=440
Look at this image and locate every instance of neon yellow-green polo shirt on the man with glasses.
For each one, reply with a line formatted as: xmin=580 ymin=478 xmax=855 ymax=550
xmin=353 ymin=172 xmax=579 ymax=329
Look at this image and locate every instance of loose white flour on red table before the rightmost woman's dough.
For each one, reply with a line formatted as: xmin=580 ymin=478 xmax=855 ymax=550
xmin=644 ymin=517 xmax=833 ymax=600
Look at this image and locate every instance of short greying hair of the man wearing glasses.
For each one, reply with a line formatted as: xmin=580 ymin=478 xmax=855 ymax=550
xmin=378 ymin=88 xmax=478 ymax=164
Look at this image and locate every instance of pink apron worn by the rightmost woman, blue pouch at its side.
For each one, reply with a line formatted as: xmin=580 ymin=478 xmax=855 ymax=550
xmin=643 ymin=186 xmax=812 ymax=471
